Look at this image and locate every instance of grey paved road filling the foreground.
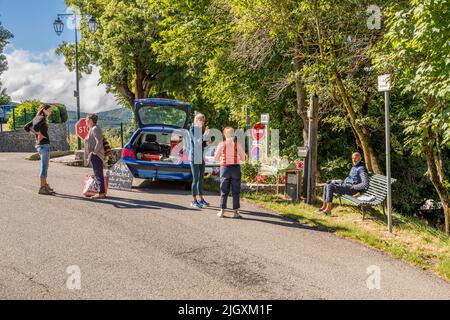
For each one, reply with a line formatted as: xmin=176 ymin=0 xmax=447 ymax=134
xmin=0 ymin=153 xmax=450 ymax=299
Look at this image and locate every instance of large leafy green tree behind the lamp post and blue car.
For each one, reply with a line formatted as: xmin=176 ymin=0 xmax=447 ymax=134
xmin=57 ymin=0 xmax=188 ymax=112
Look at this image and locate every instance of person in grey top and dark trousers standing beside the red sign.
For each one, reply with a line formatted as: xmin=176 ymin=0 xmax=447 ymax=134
xmin=84 ymin=113 xmax=106 ymax=199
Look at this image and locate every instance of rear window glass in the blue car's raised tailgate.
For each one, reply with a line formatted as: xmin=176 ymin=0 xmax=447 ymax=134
xmin=139 ymin=105 xmax=187 ymax=128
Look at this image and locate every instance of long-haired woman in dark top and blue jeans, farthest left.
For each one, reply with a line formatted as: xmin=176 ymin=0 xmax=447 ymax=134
xmin=25 ymin=104 xmax=55 ymax=195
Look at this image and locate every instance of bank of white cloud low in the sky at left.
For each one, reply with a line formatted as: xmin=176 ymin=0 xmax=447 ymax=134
xmin=1 ymin=49 xmax=119 ymax=112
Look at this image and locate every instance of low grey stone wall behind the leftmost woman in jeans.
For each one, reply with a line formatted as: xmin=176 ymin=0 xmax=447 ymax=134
xmin=0 ymin=123 xmax=70 ymax=152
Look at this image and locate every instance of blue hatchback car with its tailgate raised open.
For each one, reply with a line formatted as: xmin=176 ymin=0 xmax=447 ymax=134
xmin=122 ymin=98 xmax=192 ymax=182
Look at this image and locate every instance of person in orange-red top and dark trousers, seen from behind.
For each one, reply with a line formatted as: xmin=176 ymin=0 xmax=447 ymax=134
xmin=214 ymin=127 xmax=245 ymax=218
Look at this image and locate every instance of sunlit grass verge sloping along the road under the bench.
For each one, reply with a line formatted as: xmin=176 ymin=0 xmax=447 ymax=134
xmin=205 ymin=179 xmax=450 ymax=281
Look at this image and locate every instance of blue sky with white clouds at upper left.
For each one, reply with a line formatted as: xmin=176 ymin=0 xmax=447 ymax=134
xmin=0 ymin=0 xmax=119 ymax=112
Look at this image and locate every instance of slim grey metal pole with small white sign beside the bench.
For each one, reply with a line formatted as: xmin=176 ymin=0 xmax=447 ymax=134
xmin=378 ymin=74 xmax=392 ymax=233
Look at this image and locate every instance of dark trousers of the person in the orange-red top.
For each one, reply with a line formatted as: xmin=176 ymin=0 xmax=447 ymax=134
xmin=220 ymin=165 xmax=241 ymax=210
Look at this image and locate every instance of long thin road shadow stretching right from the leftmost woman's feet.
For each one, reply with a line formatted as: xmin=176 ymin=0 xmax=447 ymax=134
xmin=55 ymin=194 xmax=196 ymax=211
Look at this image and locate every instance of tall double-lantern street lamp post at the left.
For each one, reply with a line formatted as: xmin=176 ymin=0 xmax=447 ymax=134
xmin=53 ymin=13 xmax=97 ymax=150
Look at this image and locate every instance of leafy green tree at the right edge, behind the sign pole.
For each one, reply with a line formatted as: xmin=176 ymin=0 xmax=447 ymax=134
xmin=377 ymin=0 xmax=450 ymax=233
